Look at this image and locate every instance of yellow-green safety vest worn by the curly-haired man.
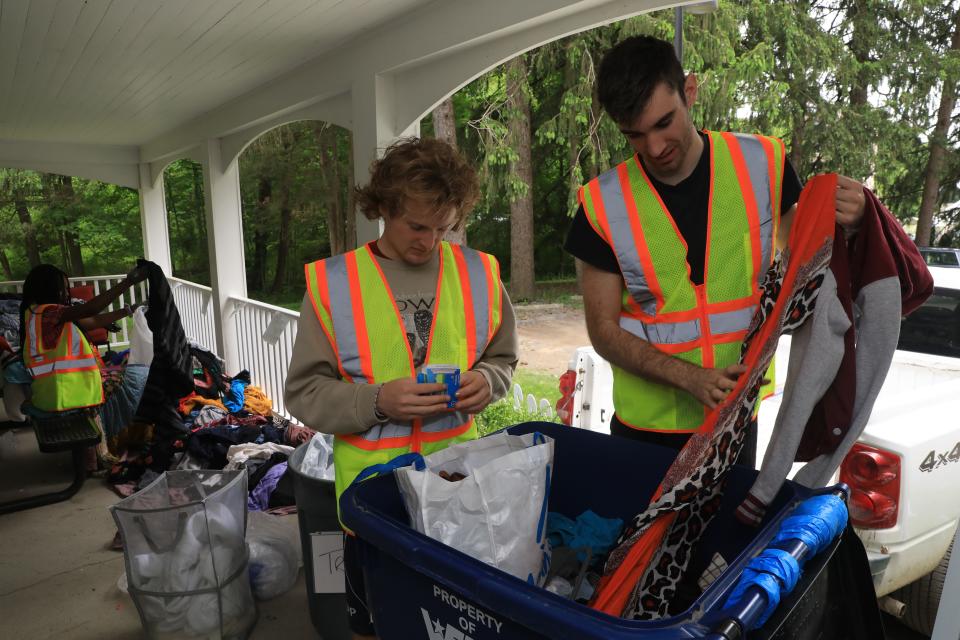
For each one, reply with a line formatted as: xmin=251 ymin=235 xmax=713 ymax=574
xmin=305 ymin=242 xmax=503 ymax=508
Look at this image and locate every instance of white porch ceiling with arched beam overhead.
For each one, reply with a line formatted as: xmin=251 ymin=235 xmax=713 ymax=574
xmin=0 ymin=0 xmax=716 ymax=187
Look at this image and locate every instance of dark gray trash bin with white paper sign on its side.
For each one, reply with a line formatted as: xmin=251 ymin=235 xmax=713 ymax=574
xmin=287 ymin=443 xmax=352 ymax=640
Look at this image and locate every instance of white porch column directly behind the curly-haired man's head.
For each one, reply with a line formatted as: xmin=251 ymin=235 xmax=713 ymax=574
xmin=352 ymin=76 xmax=420 ymax=245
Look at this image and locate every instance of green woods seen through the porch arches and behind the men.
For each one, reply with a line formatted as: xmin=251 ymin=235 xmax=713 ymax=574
xmin=0 ymin=0 xmax=960 ymax=284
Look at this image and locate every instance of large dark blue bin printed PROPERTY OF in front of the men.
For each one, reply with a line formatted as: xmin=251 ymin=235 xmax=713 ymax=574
xmin=340 ymin=422 xmax=840 ymax=640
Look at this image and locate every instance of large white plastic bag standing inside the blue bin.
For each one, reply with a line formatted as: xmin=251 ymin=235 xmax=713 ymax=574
xmin=396 ymin=432 xmax=554 ymax=585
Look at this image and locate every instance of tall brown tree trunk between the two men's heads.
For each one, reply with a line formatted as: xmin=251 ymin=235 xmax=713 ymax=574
xmin=506 ymin=56 xmax=535 ymax=300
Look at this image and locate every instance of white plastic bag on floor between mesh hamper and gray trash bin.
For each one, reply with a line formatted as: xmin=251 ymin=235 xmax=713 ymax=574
xmin=247 ymin=511 xmax=303 ymax=600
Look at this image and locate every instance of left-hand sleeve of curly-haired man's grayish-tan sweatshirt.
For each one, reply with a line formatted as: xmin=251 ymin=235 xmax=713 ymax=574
xmin=283 ymin=295 xmax=380 ymax=434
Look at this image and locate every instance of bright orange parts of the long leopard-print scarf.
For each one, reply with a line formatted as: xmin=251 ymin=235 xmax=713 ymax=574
xmin=590 ymin=174 xmax=837 ymax=617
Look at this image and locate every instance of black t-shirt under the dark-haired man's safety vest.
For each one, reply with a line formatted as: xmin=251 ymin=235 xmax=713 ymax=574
xmin=563 ymin=132 xmax=803 ymax=284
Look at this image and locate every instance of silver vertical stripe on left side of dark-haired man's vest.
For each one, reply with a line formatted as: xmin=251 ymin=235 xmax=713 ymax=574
xmin=598 ymin=168 xmax=657 ymax=316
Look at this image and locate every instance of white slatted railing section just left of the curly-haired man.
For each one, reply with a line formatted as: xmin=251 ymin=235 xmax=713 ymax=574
xmin=230 ymin=298 xmax=300 ymax=418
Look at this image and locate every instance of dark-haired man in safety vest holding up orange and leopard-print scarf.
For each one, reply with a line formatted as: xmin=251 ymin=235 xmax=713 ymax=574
xmin=565 ymin=36 xmax=864 ymax=465
